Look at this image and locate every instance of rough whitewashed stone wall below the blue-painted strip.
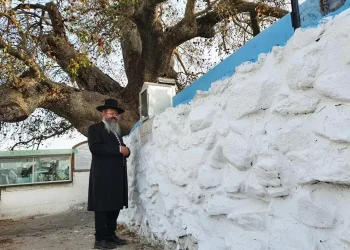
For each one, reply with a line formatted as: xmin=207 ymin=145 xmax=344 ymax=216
xmin=121 ymin=11 xmax=350 ymax=250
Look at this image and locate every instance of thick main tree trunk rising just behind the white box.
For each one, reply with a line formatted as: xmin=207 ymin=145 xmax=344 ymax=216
xmin=121 ymin=14 xmax=177 ymax=109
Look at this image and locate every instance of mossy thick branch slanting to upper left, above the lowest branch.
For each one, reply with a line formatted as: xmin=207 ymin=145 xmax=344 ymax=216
xmin=9 ymin=2 xmax=123 ymax=95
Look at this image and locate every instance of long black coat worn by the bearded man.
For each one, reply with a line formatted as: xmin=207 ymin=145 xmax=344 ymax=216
xmin=88 ymin=122 xmax=128 ymax=211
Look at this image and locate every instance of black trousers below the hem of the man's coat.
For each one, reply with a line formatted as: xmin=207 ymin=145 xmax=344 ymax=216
xmin=95 ymin=210 xmax=120 ymax=241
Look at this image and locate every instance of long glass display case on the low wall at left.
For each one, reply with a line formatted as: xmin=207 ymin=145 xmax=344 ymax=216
xmin=0 ymin=149 xmax=72 ymax=187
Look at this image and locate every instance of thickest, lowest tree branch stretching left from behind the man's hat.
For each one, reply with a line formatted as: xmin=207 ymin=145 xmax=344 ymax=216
xmin=0 ymin=74 xmax=138 ymax=135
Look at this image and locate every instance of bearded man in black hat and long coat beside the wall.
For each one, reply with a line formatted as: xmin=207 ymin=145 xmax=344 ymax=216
xmin=88 ymin=99 xmax=130 ymax=249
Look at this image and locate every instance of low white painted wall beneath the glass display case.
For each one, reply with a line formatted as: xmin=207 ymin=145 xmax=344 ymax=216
xmin=0 ymin=172 xmax=89 ymax=219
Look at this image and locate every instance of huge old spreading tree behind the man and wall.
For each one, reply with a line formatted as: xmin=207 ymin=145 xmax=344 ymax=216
xmin=0 ymin=0 xmax=288 ymax=148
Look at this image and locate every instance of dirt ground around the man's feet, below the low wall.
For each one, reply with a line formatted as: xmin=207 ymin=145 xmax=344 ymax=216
xmin=0 ymin=208 xmax=162 ymax=250
